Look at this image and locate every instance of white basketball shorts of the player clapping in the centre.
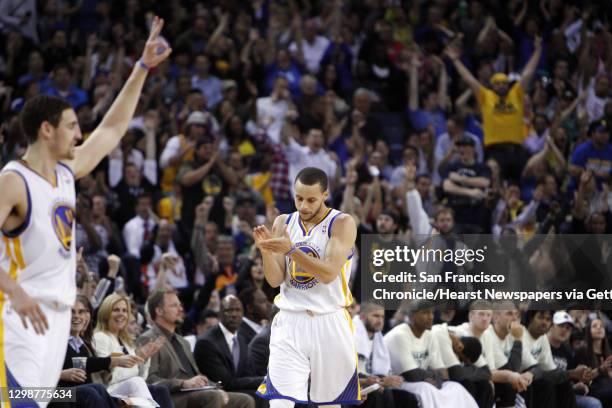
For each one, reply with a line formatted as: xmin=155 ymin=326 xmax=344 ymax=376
xmin=257 ymin=309 xmax=361 ymax=405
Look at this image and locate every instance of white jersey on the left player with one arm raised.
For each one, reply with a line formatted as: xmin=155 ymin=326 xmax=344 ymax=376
xmin=0 ymin=161 xmax=76 ymax=307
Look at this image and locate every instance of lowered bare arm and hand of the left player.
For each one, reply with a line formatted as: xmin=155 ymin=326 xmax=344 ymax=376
xmin=0 ymin=172 xmax=49 ymax=334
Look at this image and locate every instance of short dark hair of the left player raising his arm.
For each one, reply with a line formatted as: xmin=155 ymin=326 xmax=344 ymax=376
xmin=19 ymin=95 xmax=72 ymax=145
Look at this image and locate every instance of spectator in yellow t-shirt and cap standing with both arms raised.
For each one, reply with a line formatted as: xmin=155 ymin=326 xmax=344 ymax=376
xmin=446 ymin=37 xmax=542 ymax=181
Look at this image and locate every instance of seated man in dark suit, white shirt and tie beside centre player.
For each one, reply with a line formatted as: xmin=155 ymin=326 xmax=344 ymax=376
xmin=193 ymin=295 xmax=263 ymax=395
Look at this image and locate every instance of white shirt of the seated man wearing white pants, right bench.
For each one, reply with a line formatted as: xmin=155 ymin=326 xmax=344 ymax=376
xmin=385 ymin=323 xmax=444 ymax=374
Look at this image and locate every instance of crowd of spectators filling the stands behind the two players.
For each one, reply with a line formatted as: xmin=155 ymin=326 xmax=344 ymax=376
xmin=0 ymin=0 xmax=612 ymax=407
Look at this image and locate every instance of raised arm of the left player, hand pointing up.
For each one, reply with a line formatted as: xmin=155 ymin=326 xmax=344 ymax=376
xmin=67 ymin=17 xmax=172 ymax=178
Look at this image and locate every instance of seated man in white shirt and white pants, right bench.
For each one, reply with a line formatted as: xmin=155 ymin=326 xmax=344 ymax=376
xmin=385 ymin=305 xmax=478 ymax=408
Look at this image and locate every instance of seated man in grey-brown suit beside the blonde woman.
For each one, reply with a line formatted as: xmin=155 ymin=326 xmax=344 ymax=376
xmin=139 ymin=290 xmax=255 ymax=408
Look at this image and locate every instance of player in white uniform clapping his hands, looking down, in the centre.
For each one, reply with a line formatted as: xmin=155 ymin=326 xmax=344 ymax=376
xmin=254 ymin=167 xmax=360 ymax=408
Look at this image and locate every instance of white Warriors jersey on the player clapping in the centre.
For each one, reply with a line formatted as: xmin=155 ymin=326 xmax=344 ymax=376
xmin=274 ymin=208 xmax=354 ymax=314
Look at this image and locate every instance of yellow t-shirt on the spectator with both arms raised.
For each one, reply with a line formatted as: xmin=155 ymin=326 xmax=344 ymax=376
xmin=478 ymin=82 xmax=525 ymax=147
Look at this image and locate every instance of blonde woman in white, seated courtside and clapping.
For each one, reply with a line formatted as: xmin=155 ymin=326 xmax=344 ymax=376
xmin=92 ymin=293 xmax=172 ymax=407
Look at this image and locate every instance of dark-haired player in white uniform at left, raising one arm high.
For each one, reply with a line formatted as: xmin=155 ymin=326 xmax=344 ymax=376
xmin=0 ymin=18 xmax=171 ymax=406
